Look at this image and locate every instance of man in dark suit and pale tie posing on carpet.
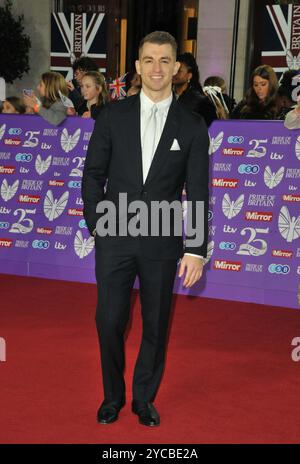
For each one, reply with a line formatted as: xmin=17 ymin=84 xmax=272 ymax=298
xmin=82 ymin=31 xmax=209 ymax=426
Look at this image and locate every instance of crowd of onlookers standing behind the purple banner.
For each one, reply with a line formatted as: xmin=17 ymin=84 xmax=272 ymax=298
xmin=0 ymin=53 xmax=300 ymax=128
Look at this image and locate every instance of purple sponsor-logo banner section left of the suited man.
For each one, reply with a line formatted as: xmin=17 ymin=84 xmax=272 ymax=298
xmin=0 ymin=115 xmax=94 ymax=281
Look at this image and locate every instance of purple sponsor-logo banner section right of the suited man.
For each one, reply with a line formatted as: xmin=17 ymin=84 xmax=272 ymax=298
xmin=185 ymin=121 xmax=300 ymax=308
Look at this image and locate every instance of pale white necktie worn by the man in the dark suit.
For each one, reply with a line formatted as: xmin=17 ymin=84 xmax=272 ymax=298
xmin=142 ymin=105 xmax=158 ymax=183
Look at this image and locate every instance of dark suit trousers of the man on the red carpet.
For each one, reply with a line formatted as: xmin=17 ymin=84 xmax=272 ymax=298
xmin=96 ymin=237 xmax=177 ymax=404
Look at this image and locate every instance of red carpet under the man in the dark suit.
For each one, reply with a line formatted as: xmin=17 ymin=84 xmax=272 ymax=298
xmin=0 ymin=275 xmax=300 ymax=444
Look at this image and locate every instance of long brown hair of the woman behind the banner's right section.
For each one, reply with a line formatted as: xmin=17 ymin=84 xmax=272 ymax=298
xmin=241 ymin=64 xmax=278 ymax=116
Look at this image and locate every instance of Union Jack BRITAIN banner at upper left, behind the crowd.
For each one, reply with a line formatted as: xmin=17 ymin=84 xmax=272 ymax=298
xmin=51 ymin=13 xmax=107 ymax=80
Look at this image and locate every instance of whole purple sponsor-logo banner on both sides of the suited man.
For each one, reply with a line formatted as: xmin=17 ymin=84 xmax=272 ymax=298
xmin=0 ymin=115 xmax=300 ymax=308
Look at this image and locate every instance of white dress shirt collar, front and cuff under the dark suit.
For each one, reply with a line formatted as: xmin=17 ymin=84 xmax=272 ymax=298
xmin=140 ymin=90 xmax=203 ymax=259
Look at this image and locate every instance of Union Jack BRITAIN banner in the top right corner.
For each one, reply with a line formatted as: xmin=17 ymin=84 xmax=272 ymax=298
xmin=261 ymin=4 xmax=300 ymax=74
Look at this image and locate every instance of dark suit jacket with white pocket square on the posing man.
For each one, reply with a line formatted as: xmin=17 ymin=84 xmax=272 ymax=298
xmin=82 ymin=94 xmax=209 ymax=259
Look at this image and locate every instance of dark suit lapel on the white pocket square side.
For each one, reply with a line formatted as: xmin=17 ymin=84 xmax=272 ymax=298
xmin=144 ymin=97 xmax=178 ymax=185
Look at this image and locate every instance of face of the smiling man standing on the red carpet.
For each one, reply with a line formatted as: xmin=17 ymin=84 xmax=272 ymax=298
xmin=136 ymin=42 xmax=180 ymax=92
